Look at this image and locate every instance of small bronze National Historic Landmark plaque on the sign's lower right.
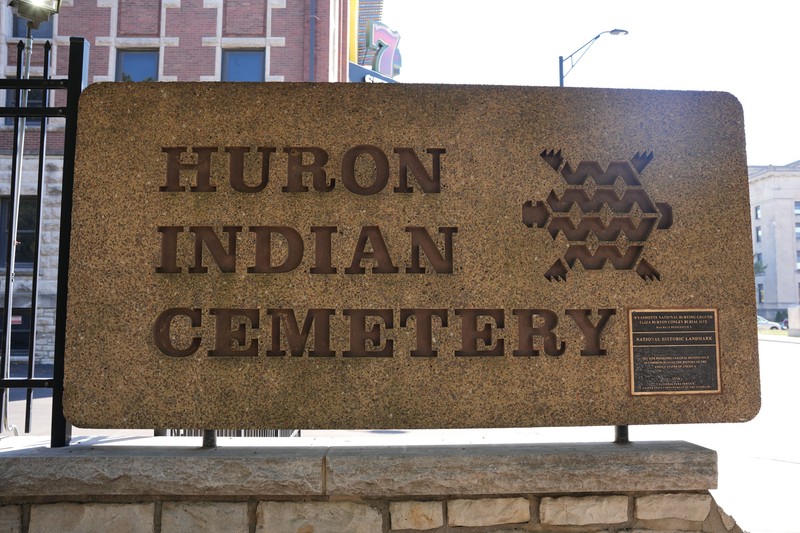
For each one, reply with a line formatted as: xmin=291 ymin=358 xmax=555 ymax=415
xmin=629 ymin=309 xmax=720 ymax=394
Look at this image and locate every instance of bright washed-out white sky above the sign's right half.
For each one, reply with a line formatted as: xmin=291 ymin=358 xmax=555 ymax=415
xmin=382 ymin=0 xmax=800 ymax=165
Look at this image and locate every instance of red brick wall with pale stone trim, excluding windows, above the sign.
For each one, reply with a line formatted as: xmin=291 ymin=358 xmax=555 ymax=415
xmin=3 ymin=0 xmax=348 ymax=81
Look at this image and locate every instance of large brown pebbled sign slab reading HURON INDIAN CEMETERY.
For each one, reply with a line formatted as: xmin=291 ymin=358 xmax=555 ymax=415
xmin=65 ymin=83 xmax=760 ymax=428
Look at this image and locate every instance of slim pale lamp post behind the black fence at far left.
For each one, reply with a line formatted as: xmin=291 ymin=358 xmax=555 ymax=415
xmin=0 ymin=0 xmax=61 ymax=434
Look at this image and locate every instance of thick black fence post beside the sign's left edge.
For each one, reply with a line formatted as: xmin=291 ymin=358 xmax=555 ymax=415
xmin=50 ymin=37 xmax=89 ymax=448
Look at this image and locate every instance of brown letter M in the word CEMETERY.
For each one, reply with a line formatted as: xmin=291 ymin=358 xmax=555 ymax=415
xmin=267 ymin=309 xmax=336 ymax=357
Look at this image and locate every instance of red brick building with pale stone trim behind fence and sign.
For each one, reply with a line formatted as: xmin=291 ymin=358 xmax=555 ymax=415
xmin=0 ymin=0 xmax=383 ymax=361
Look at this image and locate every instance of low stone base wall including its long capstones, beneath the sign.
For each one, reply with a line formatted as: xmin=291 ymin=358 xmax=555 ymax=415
xmin=0 ymin=438 xmax=741 ymax=533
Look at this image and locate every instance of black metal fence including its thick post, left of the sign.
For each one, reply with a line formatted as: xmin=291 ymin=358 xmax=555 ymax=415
xmin=0 ymin=37 xmax=89 ymax=447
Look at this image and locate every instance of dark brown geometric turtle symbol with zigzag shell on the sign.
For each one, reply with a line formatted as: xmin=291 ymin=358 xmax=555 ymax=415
xmin=522 ymin=149 xmax=672 ymax=281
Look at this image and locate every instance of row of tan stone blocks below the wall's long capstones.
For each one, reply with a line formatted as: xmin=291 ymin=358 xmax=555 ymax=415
xmin=0 ymin=492 xmax=741 ymax=533
